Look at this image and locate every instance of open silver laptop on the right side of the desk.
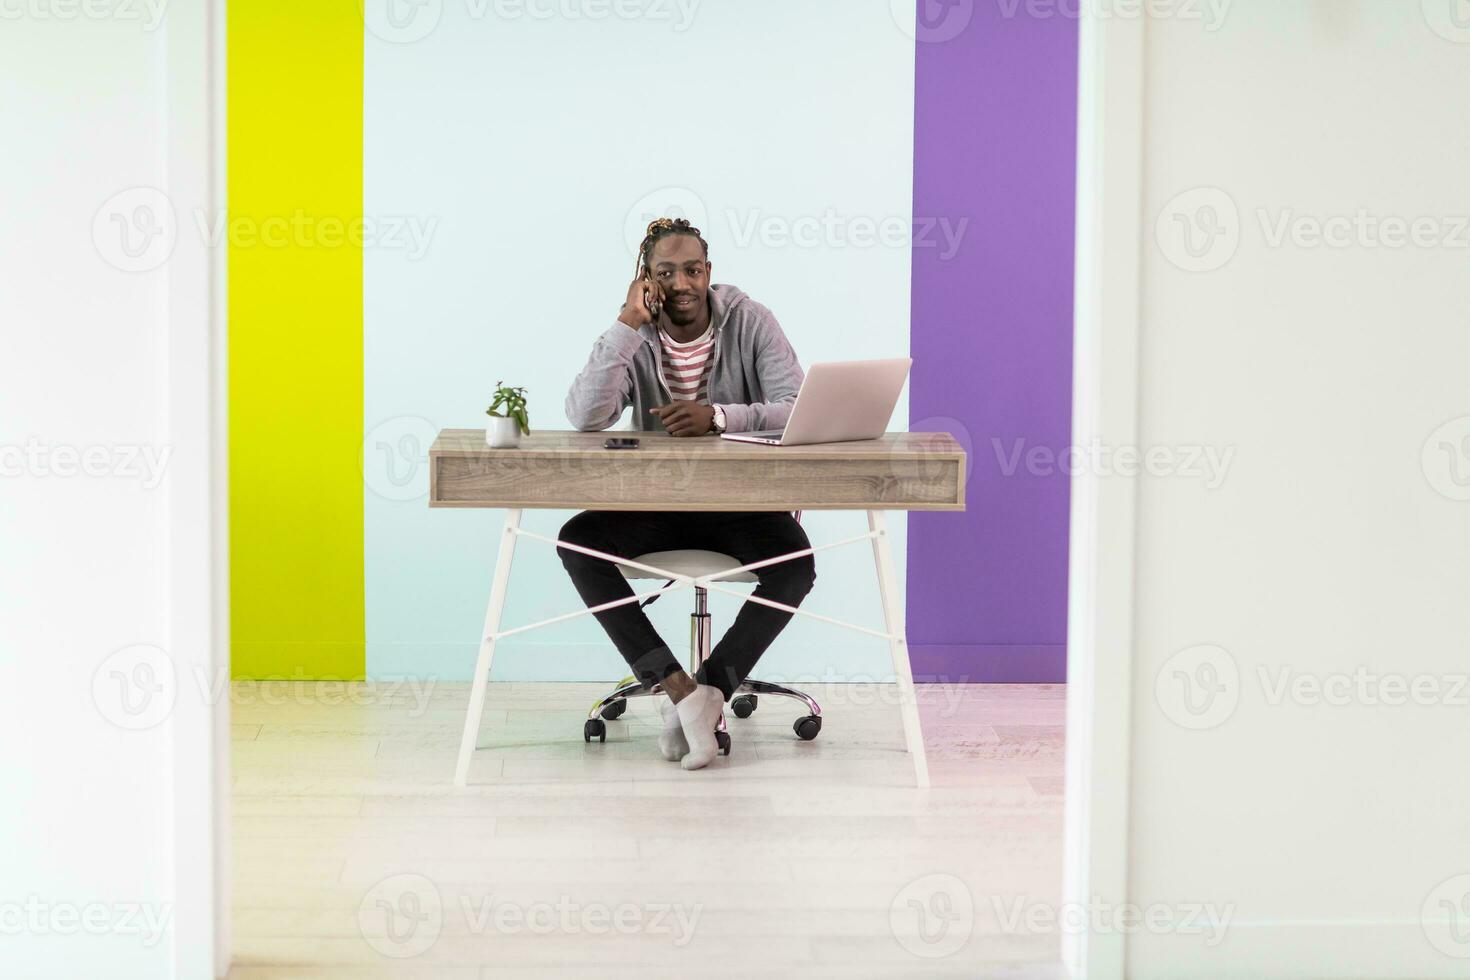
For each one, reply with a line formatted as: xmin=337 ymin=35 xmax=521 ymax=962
xmin=723 ymin=357 xmax=913 ymax=445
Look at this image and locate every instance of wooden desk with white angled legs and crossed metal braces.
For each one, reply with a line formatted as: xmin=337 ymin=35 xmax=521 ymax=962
xmin=429 ymin=429 xmax=966 ymax=786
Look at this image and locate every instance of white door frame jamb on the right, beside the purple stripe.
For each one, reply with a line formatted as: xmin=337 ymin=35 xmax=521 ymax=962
xmin=1063 ymin=4 xmax=1147 ymax=980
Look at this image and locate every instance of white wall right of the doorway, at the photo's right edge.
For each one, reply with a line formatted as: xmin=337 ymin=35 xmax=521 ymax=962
xmin=1127 ymin=0 xmax=1470 ymax=980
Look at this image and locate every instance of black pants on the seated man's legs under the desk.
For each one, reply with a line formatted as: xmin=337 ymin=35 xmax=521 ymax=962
xmin=557 ymin=510 xmax=817 ymax=701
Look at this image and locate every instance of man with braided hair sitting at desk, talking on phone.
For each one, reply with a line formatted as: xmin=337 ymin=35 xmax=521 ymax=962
xmin=557 ymin=217 xmax=816 ymax=770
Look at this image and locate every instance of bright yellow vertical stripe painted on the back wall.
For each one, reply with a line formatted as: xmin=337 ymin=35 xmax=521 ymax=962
xmin=226 ymin=0 xmax=365 ymax=677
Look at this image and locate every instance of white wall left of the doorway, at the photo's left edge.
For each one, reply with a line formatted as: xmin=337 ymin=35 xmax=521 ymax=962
xmin=0 ymin=1 xmax=210 ymax=979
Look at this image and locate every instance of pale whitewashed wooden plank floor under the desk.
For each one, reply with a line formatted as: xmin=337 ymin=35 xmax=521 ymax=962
xmin=229 ymin=682 xmax=1064 ymax=980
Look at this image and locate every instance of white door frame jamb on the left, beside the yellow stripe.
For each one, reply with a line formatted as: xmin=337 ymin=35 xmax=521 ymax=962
xmin=162 ymin=0 xmax=229 ymax=977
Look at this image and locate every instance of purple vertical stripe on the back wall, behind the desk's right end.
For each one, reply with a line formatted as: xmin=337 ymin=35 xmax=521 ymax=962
xmin=907 ymin=0 xmax=1078 ymax=683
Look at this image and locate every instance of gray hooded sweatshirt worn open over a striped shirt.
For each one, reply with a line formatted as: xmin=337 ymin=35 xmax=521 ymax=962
xmin=566 ymin=285 xmax=806 ymax=432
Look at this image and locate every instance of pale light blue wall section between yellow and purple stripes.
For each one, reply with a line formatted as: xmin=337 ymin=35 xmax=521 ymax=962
xmin=363 ymin=0 xmax=913 ymax=680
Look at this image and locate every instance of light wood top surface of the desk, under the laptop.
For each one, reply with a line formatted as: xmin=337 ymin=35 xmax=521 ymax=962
xmin=429 ymin=429 xmax=964 ymax=460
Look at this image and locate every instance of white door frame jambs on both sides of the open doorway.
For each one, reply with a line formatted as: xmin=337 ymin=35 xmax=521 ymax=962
xmin=174 ymin=0 xmax=1145 ymax=980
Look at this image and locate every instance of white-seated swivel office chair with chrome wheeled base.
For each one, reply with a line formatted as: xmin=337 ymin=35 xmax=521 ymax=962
xmin=582 ymin=510 xmax=822 ymax=755
